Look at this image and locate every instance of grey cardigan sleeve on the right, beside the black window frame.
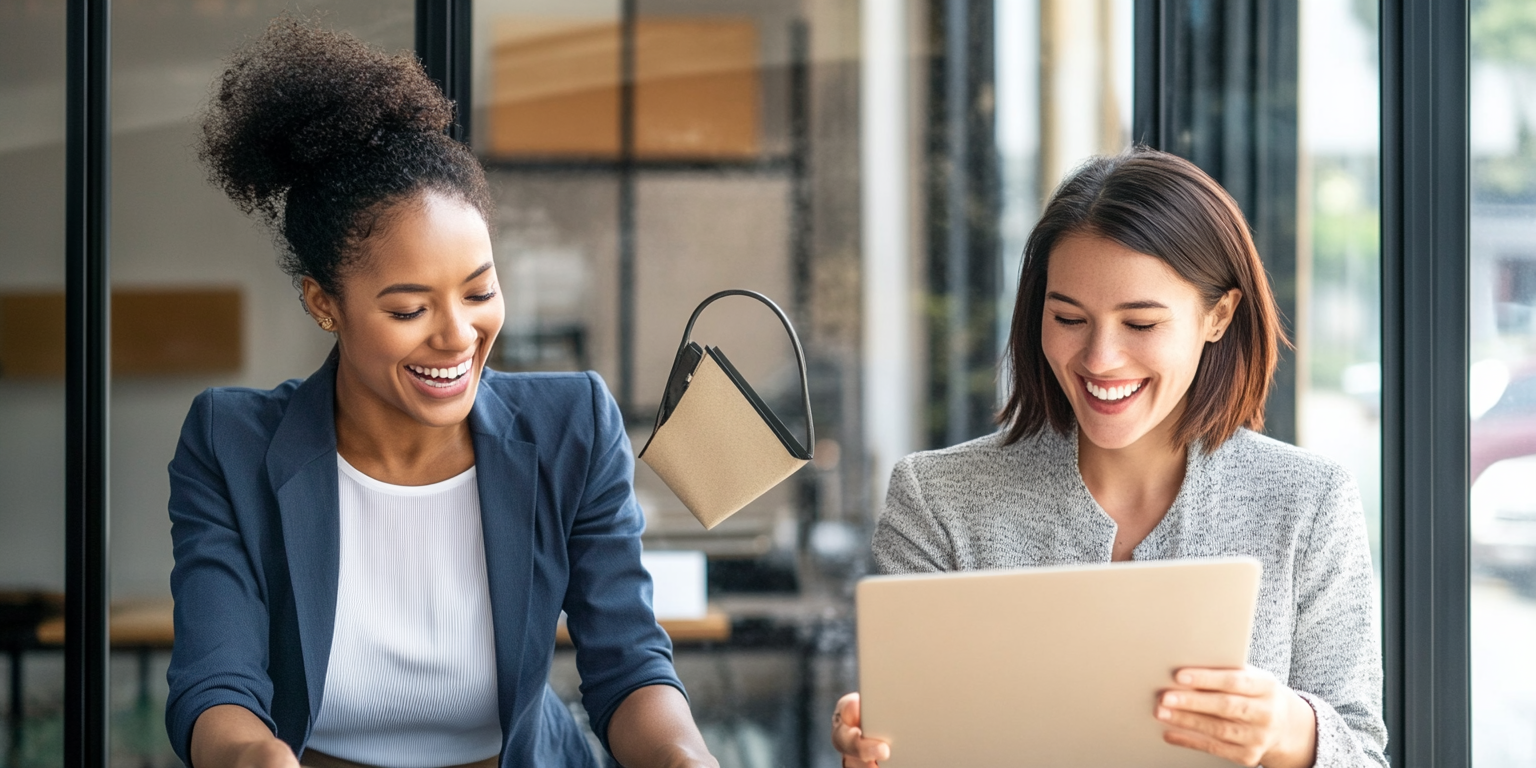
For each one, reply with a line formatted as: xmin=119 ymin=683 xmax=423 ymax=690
xmin=1289 ymin=470 xmax=1387 ymax=768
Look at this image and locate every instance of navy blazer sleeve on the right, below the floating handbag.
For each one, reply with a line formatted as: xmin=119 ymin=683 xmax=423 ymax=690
xmin=562 ymin=373 xmax=687 ymax=753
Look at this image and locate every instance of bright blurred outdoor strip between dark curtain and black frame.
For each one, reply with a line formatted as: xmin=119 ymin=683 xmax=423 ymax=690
xmin=1295 ymin=0 xmax=1381 ymax=573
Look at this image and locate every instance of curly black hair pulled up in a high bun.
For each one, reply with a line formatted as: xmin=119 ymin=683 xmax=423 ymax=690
xmin=198 ymin=15 xmax=490 ymax=295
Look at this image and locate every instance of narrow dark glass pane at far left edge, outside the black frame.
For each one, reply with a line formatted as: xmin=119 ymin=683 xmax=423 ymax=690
xmin=0 ymin=3 xmax=65 ymax=766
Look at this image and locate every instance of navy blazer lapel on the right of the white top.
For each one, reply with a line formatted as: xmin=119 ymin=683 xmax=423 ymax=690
xmin=470 ymin=387 xmax=548 ymax=733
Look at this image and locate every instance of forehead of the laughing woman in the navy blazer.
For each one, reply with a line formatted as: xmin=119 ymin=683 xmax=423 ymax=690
xmin=353 ymin=194 xmax=492 ymax=286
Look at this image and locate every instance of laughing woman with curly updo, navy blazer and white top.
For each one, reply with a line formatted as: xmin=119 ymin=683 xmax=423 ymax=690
xmin=166 ymin=18 xmax=714 ymax=768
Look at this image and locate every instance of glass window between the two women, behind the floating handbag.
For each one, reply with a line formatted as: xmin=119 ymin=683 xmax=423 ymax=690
xmin=472 ymin=0 xmax=1132 ymax=765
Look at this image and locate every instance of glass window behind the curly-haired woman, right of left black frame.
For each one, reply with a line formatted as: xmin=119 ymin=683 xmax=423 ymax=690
xmin=107 ymin=0 xmax=415 ymax=765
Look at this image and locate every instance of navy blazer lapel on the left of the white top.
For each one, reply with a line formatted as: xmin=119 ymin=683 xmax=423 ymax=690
xmin=267 ymin=350 xmax=341 ymax=728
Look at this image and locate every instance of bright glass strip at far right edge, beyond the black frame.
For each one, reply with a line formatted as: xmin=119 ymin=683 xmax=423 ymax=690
xmin=1467 ymin=0 xmax=1536 ymax=768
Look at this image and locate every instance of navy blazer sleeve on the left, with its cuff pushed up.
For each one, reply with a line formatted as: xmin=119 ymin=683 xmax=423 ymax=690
xmin=166 ymin=392 xmax=275 ymax=765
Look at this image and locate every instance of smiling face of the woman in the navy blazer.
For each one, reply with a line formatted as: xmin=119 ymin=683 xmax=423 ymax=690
xmin=304 ymin=192 xmax=504 ymax=427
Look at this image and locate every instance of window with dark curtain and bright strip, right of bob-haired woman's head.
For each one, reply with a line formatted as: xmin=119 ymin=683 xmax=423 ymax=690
xmin=1138 ymin=0 xmax=1381 ymax=586
